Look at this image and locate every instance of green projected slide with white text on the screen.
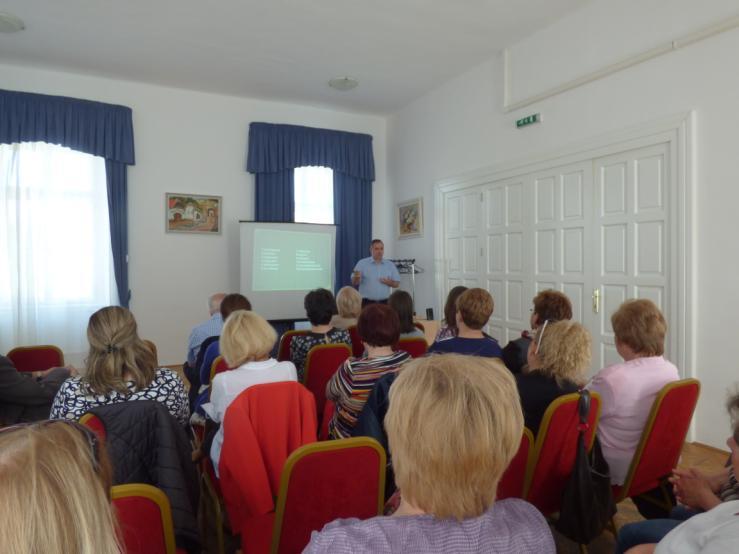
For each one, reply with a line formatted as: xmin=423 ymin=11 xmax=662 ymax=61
xmin=252 ymin=229 xmax=333 ymax=291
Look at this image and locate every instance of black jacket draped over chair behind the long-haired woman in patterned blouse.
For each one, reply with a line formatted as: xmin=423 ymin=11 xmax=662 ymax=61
xmin=90 ymin=400 xmax=200 ymax=552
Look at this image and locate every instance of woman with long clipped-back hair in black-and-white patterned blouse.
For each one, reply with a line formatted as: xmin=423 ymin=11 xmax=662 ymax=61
xmin=50 ymin=306 xmax=190 ymax=425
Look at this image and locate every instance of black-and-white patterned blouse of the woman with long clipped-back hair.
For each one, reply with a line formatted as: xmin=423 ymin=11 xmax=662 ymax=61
xmin=49 ymin=367 xmax=190 ymax=425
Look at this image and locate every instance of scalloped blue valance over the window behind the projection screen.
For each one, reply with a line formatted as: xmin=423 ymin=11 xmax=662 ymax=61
xmin=246 ymin=123 xmax=375 ymax=181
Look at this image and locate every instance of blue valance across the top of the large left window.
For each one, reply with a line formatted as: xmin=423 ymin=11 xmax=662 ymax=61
xmin=0 ymin=90 xmax=135 ymax=165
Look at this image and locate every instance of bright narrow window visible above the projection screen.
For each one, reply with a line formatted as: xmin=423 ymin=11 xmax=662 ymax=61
xmin=294 ymin=166 xmax=334 ymax=225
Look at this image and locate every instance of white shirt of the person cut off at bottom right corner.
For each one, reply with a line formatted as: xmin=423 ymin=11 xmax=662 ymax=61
xmin=654 ymin=500 xmax=739 ymax=554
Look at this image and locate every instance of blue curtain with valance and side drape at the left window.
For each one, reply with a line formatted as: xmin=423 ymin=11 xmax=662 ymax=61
xmin=0 ymin=90 xmax=135 ymax=307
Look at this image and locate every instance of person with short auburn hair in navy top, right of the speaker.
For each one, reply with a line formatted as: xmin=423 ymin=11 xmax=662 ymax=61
xmin=429 ymin=289 xmax=502 ymax=358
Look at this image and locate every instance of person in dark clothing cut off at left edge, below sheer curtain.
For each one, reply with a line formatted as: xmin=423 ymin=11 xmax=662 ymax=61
xmin=0 ymin=356 xmax=77 ymax=427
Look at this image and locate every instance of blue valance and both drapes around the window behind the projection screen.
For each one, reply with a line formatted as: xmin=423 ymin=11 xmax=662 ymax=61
xmin=246 ymin=123 xmax=375 ymax=290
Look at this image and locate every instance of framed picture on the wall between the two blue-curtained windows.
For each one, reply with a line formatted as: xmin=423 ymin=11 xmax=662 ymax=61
xmin=166 ymin=192 xmax=221 ymax=234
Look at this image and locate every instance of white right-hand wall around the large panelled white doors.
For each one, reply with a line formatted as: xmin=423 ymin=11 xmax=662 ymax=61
xmin=388 ymin=0 xmax=739 ymax=446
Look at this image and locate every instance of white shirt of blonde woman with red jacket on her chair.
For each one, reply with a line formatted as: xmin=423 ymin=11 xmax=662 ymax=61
xmin=203 ymin=358 xmax=298 ymax=475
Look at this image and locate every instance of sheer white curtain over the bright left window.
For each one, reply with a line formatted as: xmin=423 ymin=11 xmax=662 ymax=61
xmin=0 ymin=142 xmax=117 ymax=364
